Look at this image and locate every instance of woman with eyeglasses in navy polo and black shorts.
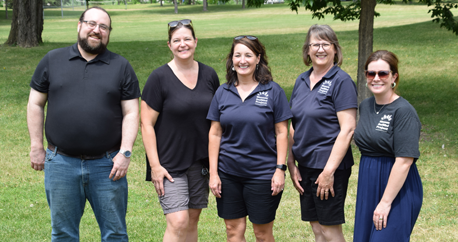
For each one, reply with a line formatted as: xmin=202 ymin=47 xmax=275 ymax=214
xmin=288 ymin=25 xmax=358 ymax=241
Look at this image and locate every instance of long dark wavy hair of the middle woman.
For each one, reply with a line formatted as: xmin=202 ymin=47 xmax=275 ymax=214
xmin=226 ymin=37 xmax=272 ymax=85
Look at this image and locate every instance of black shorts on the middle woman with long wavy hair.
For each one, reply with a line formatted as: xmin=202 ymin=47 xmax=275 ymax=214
xmin=216 ymin=171 xmax=283 ymax=224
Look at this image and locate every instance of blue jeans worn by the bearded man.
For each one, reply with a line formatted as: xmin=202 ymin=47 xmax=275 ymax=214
xmin=45 ymin=147 xmax=128 ymax=242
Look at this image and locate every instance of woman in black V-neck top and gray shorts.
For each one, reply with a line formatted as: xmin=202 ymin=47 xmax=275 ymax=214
xmin=141 ymin=19 xmax=219 ymax=242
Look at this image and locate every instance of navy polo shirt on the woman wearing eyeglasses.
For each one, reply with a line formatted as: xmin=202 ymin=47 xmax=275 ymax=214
xmin=290 ymin=65 xmax=358 ymax=170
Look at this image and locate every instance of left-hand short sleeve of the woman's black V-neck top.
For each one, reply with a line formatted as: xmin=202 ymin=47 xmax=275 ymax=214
xmin=142 ymin=69 xmax=165 ymax=113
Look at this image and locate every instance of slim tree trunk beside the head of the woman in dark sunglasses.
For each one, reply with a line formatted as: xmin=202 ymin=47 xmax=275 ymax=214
xmin=357 ymin=0 xmax=377 ymax=113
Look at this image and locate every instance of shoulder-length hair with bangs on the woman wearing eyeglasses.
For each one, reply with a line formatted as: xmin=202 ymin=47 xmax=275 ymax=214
xmin=302 ymin=24 xmax=343 ymax=66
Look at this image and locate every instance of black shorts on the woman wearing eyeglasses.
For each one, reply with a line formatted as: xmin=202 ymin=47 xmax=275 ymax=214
xmin=299 ymin=166 xmax=351 ymax=225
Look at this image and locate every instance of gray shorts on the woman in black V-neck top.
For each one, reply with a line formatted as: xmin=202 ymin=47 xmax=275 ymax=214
xmin=159 ymin=162 xmax=209 ymax=214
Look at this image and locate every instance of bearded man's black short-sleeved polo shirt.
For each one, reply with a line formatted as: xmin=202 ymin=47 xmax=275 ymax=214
xmin=30 ymin=44 xmax=140 ymax=155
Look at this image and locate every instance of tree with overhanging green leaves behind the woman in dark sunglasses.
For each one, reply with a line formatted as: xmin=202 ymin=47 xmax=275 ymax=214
xmin=288 ymin=0 xmax=458 ymax=103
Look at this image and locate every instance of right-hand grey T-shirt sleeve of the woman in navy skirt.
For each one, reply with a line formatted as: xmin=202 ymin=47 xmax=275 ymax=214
xmin=393 ymin=105 xmax=421 ymax=158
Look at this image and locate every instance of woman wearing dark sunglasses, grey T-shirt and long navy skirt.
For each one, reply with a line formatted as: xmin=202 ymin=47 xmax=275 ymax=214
xmin=354 ymin=50 xmax=423 ymax=242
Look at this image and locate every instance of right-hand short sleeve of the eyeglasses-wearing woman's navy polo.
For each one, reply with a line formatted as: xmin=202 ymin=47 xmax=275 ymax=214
xmin=333 ymin=71 xmax=358 ymax=112
